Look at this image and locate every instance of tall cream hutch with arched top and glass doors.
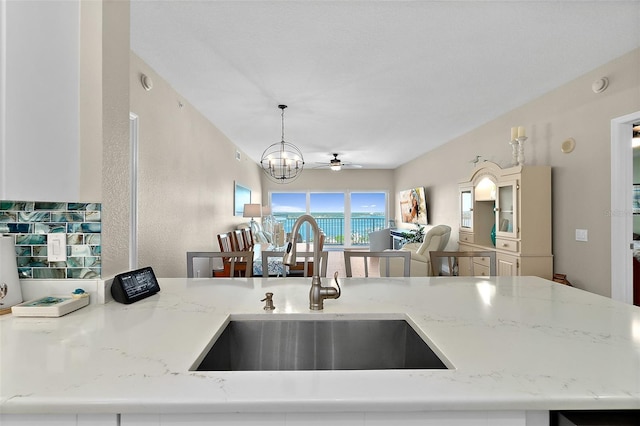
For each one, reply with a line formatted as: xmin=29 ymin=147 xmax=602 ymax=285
xmin=459 ymin=162 xmax=553 ymax=279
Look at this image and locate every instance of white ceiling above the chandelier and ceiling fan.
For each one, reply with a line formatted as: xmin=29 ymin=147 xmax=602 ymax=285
xmin=131 ymin=0 xmax=640 ymax=168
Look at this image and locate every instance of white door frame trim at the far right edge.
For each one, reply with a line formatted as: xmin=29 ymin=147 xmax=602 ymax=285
xmin=609 ymin=111 xmax=640 ymax=304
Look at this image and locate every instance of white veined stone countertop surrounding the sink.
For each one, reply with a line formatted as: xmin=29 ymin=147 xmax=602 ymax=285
xmin=0 ymin=277 xmax=640 ymax=413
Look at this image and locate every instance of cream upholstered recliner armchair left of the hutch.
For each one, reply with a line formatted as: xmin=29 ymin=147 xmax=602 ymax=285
xmin=380 ymin=225 xmax=451 ymax=277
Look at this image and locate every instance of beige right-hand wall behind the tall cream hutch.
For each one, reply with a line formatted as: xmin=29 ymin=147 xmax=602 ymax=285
xmin=395 ymin=49 xmax=640 ymax=296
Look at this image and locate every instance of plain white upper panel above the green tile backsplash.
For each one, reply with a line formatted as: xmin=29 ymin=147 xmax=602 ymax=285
xmin=0 ymin=0 xmax=80 ymax=201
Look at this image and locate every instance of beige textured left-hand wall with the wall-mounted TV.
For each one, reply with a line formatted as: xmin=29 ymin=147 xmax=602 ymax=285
xmin=129 ymin=53 xmax=262 ymax=277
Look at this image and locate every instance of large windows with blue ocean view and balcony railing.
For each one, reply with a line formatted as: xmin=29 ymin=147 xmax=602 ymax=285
xmin=270 ymin=192 xmax=387 ymax=247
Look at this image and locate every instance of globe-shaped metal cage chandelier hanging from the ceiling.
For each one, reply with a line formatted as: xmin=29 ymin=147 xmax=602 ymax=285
xmin=260 ymin=105 xmax=304 ymax=183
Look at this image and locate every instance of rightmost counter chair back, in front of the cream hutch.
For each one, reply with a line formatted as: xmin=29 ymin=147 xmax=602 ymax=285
xmin=429 ymin=250 xmax=496 ymax=277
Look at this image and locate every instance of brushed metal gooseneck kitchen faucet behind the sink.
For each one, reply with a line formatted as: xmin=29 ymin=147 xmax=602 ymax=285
xmin=282 ymin=214 xmax=340 ymax=311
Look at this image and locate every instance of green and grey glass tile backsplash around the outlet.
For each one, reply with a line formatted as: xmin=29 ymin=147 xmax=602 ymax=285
xmin=0 ymin=200 xmax=102 ymax=279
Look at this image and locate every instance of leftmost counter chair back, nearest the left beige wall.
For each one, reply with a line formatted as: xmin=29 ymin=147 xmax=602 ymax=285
xmin=187 ymin=250 xmax=253 ymax=278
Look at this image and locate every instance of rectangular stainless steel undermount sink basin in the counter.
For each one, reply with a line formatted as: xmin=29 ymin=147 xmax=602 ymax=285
xmin=193 ymin=319 xmax=447 ymax=371
